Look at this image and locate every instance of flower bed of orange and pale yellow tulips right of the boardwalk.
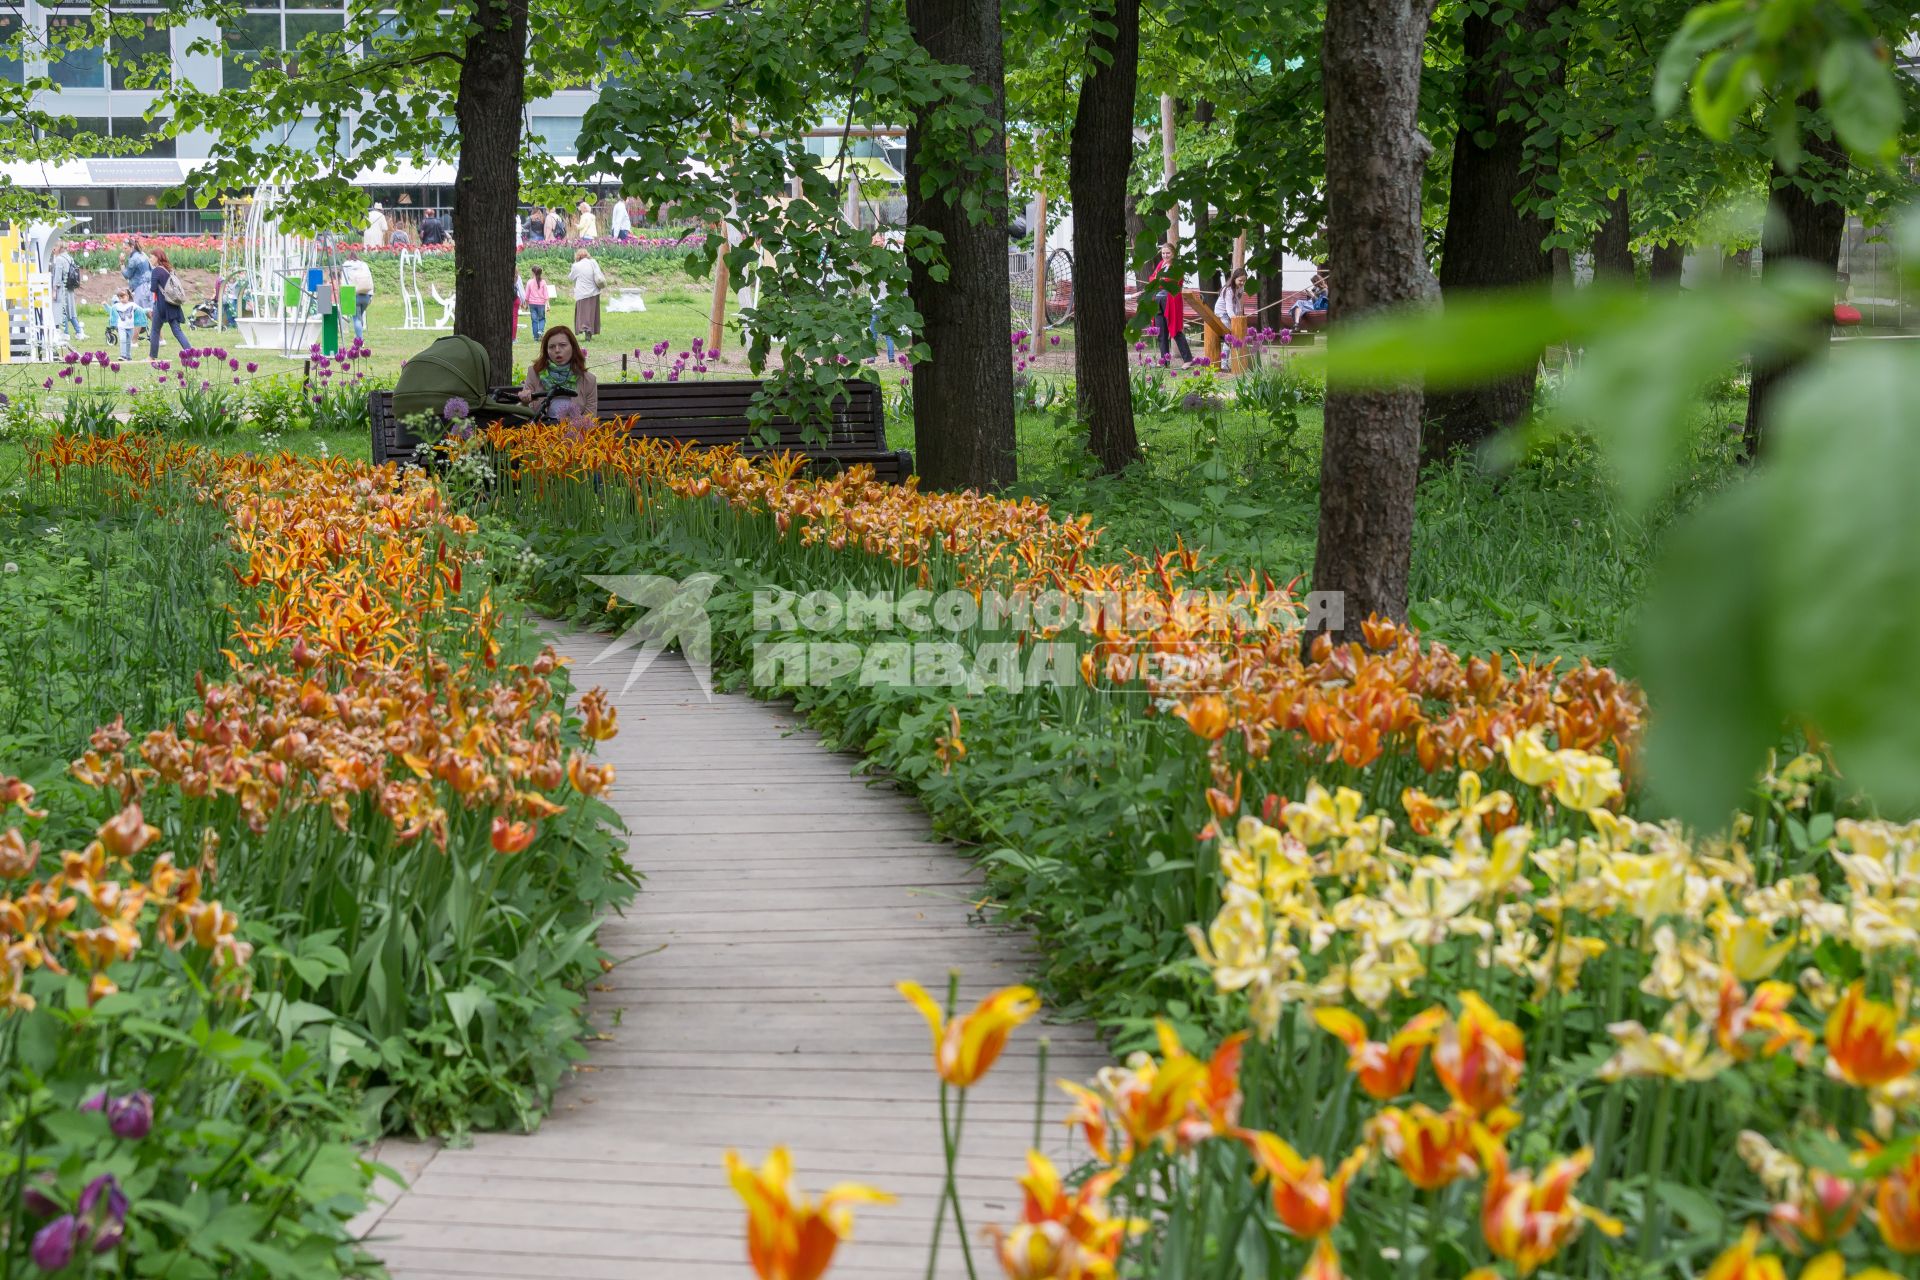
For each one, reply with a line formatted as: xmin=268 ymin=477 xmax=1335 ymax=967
xmin=487 ymin=430 xmax=1920 ymax=1280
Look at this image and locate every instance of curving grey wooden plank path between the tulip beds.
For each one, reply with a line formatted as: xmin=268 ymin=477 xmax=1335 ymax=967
xmin=361 ymin=633 xmax=1108 ymax=1280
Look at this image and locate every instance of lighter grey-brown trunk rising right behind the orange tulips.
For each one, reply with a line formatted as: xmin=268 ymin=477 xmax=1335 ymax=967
xmin=1313 ymin=0 xmax=1432 ymax=639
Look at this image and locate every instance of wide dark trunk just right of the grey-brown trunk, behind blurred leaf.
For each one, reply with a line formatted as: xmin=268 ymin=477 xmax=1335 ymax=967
xmin=1423 ymin=0 xmax=1571 ymax=461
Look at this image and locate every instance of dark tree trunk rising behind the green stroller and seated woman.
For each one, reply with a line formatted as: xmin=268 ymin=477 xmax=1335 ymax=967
xmin=453 ymin=0 xmax=528 ymax=382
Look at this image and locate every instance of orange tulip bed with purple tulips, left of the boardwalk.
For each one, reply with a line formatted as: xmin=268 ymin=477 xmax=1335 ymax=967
xmin=0 ymin=436 xmax=634 ymax=1276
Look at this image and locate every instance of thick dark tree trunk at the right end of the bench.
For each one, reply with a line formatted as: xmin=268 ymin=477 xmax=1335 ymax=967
xmin=906 ymin=0 xmax=1018 ymax=489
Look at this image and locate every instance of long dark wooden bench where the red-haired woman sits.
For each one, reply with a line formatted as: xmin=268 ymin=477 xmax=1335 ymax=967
xmin=367 ymin=380 xmax=914 ymax=484
